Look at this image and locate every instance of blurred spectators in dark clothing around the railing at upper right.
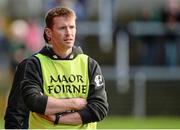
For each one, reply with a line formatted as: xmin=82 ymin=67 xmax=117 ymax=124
xmin=131 ymin=0 xmax=180 ymax=67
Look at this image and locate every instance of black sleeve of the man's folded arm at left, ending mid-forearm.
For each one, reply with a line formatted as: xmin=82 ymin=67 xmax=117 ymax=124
xmin=20 ymin=57 xmax=48 ymax=114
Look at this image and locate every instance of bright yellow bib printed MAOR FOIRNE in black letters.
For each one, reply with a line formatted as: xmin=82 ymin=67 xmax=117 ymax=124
xmin=29 ymin=54 xmax=96 ymax=129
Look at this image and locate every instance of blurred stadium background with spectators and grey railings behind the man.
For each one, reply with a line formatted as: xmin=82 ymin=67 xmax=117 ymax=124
xmin=0 ymin=0 xmax=180 ymax=128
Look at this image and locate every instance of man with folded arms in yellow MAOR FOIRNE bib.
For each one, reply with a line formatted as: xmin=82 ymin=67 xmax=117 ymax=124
xmin=5 ymin=7 xmax=108 ymax=129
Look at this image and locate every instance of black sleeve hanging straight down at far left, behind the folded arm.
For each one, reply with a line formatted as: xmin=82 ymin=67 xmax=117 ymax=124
xmin=4 ymin=63 xmax=29 ymax=129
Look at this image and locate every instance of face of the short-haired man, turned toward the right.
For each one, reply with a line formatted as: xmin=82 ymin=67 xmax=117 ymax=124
xmin=49 ymin=17 xmax=76 ymax=49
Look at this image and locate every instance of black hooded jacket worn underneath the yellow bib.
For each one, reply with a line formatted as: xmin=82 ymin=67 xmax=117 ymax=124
xmin=4 ymin=46 xmax=108 ymax=129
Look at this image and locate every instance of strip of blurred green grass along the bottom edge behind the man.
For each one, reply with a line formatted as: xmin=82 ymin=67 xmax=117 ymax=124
xmin=0 ymin=116 xmax=180 ymax=129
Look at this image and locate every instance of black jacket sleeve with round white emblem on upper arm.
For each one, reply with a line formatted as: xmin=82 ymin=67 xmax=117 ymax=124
xmin=79 ymin=58 xmax=108 ymax=124
